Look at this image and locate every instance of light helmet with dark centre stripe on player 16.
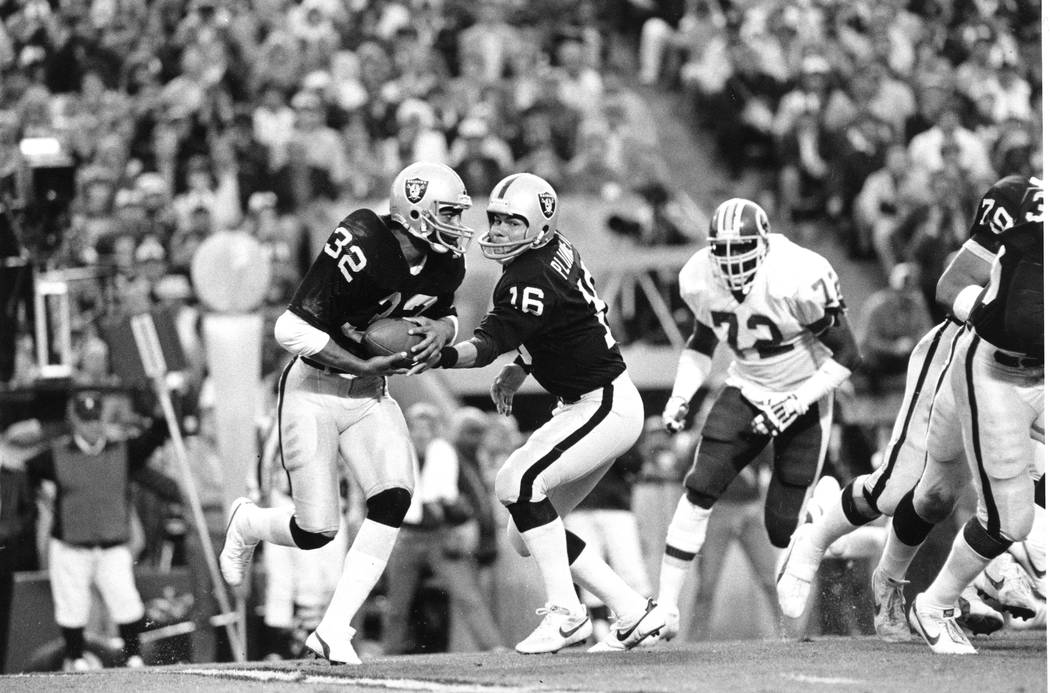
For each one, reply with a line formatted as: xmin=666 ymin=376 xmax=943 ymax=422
xmin=478 ymin=173 xmax=559 ymax=263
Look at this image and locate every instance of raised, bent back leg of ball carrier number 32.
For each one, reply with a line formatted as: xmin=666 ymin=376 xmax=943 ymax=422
xmin=218 ymin=359 xmax=348 ymax=586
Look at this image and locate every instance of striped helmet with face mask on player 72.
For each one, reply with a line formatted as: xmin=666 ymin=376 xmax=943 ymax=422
xmin=708 ymin=197 xmax=770 ymax=294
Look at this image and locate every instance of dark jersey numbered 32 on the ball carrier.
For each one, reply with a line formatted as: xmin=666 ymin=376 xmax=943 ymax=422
xmin=288 ymin=209 xmax=465 ymax=358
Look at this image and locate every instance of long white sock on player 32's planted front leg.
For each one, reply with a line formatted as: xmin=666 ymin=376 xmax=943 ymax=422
xmin=318 ymin=520 xmax=398 ymax=633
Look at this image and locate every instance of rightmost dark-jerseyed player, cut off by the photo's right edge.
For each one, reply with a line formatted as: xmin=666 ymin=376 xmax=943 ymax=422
xmin=883 ymin=180 xmax=1046 ymax=654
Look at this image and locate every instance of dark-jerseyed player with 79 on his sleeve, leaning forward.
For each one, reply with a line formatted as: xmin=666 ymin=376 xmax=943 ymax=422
xmin=777 ymin=175 xmax=1037 ymax=642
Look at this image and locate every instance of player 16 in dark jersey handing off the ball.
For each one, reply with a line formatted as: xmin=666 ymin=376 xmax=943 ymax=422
xmin=417 ymin=173 xmax=664 ymax=654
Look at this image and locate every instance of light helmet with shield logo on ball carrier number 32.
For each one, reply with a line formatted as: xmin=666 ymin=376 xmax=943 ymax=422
xmin=391 ymin=162 xmax=474 ymax=255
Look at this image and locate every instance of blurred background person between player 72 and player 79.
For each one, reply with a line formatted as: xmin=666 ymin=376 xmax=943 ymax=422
xmin=858 ymin=264 xmax=932 ymax=394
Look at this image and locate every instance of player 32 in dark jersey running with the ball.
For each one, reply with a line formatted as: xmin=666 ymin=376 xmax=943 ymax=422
xmin=219 ymin=163 xmax=473 ymax=664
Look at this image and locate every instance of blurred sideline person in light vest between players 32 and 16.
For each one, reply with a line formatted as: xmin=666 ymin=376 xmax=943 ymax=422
xmin=383 ymin=403 xmax=501 ymax=654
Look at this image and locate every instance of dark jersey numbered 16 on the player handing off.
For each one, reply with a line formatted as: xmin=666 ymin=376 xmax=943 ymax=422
xmin=476 ymin=234 xmax=627 ymax=400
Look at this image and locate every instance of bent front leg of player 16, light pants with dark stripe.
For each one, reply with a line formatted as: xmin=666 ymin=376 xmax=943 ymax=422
xmin=496 ymin=374 xmax=643 ymax=653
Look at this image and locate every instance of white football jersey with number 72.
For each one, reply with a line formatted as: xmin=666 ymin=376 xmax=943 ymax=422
xmin=678 ymin=233 xmax=842 ymax=396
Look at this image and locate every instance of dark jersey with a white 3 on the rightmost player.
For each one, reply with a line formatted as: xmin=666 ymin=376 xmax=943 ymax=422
xmin=970 ymin=181 xmax=1044 ymax=358
